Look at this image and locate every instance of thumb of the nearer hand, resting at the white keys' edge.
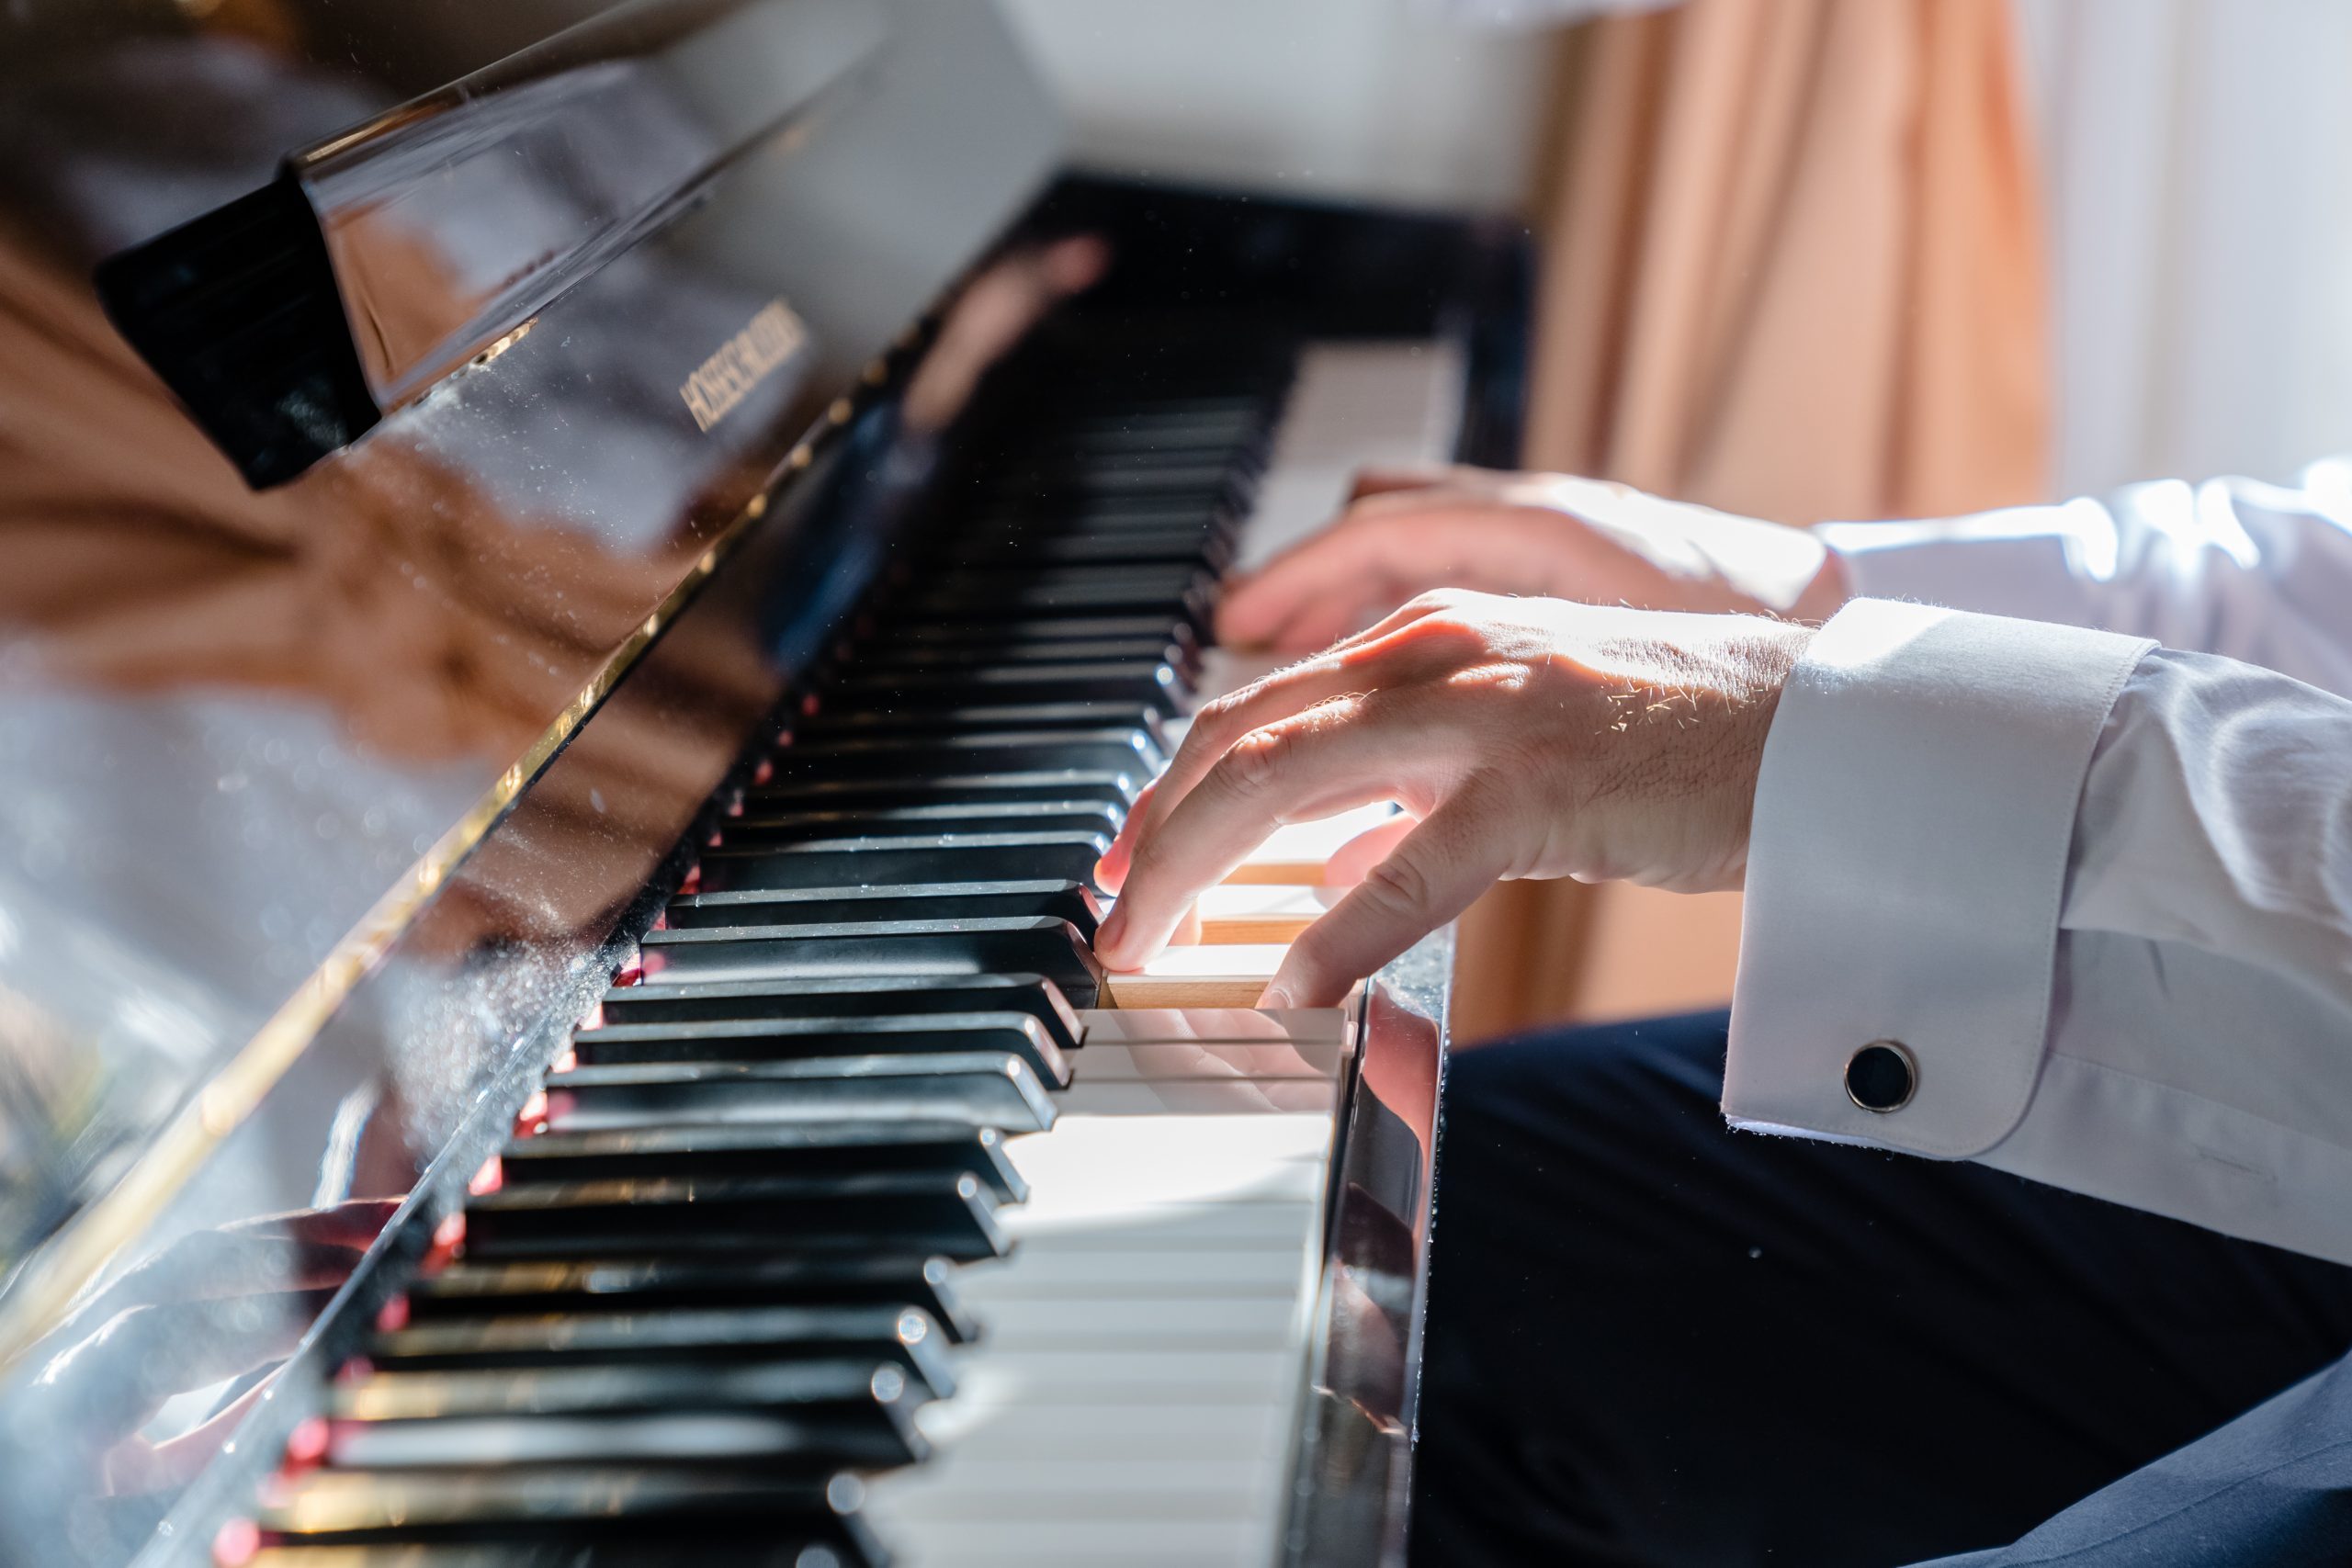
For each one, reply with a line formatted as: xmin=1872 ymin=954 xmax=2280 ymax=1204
xmin=1259 ymin=790 xmax=1510 ymax=1006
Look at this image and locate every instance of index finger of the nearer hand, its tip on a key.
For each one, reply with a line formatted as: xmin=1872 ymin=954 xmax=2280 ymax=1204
xmin=1093 ymin=694 xmax=1430 ymax=968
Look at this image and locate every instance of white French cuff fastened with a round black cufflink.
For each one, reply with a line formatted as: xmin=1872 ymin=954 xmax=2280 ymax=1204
xmin=1724 ymin=600 xmax=2154 ymax=1159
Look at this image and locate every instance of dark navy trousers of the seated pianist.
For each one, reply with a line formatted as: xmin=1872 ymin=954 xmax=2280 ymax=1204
xmin=1414 ymin=1013 xmax=2352 ymax=1568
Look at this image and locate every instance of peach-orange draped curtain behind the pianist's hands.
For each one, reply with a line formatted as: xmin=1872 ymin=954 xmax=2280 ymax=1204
xmin=1456 ymin=0 xmax=2046 ymax=1034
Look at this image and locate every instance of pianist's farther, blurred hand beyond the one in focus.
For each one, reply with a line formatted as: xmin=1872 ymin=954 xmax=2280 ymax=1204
xmin=1218 ymin=468 xmax=1847 ymax=653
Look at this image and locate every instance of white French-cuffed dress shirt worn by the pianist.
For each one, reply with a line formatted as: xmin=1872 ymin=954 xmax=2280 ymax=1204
xmin=1724 ymin=461 xmax=2352 ymax=1262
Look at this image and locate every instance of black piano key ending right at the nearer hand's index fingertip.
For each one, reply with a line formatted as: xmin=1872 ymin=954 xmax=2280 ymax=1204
xmin=639 ymin=911 xmax=1103 ymax=1006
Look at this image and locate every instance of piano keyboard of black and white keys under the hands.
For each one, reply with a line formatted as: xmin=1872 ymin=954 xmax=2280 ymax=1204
xmin=233 ymin=345 xmax=1458 ymax=1568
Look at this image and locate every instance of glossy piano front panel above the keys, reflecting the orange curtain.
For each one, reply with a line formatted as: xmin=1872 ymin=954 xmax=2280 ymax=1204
xmin=0 ymin=0 xmax=1056 ymax=1357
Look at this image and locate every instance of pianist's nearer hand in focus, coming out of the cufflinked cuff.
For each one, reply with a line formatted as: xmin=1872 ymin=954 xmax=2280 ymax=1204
xmin=1096 ymin=592 xmax=1811 ymax=1006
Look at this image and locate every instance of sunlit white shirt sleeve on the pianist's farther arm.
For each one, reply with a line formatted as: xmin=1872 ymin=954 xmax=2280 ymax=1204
xmin=1814 ymin=458 xmax=2352 ymax=696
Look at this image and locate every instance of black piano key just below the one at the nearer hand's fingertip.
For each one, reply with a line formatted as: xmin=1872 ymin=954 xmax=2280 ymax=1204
xmin=605 ymin=973 xmax=1084 ymax=1051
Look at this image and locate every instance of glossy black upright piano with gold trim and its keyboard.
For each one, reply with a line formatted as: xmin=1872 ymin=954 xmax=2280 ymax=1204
xmin=0 ymin=0 xmax=1526 ymax=1568
